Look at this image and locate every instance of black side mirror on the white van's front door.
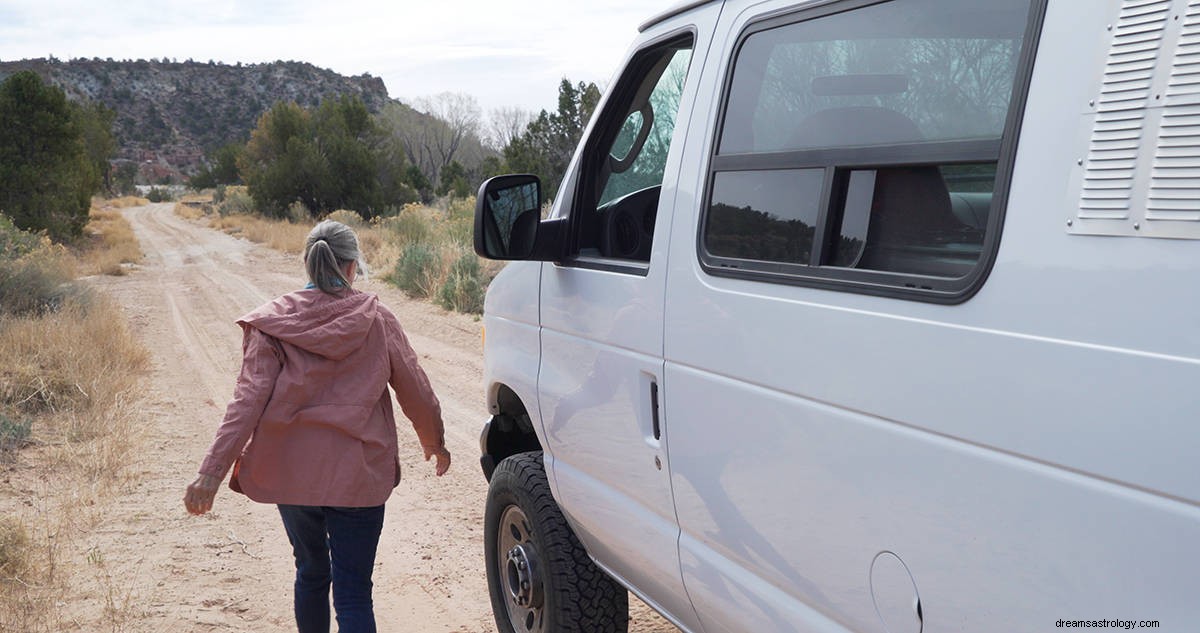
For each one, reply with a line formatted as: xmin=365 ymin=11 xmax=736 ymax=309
xmin=475 ymin=174 xmax=562 ymax=260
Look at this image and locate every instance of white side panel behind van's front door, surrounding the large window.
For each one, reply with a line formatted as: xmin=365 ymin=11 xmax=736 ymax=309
xmin=665 ymin=1 xmax=1200 ymax=633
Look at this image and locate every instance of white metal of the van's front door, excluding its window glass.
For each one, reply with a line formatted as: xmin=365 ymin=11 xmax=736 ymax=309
xmin=538 ymin=7 xmax=719 ymax=631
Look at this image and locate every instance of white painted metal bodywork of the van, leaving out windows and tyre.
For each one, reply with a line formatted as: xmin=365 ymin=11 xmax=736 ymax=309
xmin=477 ymin=0 xmax=1200 ymax=633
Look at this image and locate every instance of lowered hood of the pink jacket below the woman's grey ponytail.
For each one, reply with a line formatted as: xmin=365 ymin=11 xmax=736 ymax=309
xmin=238 ymin=289 xmax=379 ymax=361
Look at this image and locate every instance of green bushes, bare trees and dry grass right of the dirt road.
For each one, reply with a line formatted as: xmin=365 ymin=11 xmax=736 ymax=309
xmin=176 ymin=79 xmax=600 ymax=314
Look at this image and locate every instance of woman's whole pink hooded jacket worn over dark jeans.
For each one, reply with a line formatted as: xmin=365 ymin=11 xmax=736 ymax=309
xmin=200 ymin=289 xmax=444 ymax=507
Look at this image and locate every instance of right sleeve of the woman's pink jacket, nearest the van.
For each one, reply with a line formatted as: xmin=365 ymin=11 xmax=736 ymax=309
xmin=384 ymin=312 xmax=445 ymax=454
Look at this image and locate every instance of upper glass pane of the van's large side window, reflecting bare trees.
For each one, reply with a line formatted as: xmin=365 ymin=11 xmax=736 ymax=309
xmin=720 ymin=0 xmax=1027 ymax=153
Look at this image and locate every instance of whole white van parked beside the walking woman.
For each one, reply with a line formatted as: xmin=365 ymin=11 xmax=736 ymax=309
xmin=475 ymin=0 xmax=1200 ymax=633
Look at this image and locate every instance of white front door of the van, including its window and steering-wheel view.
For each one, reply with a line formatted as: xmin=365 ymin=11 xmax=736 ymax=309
xmin=539 ymin=17 xmax=716 ymax=629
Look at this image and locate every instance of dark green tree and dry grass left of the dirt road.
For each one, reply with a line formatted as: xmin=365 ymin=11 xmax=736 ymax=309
xmin=0 ymin=72 xmax=148 ymax=633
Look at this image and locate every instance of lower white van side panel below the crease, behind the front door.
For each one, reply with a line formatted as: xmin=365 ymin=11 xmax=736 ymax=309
xmin=667 ymin=363 xmax=1200 ymax=632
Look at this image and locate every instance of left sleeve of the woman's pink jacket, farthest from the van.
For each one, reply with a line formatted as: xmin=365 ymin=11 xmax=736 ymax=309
xmin=199 ymin=324 xmax=283 ymax=480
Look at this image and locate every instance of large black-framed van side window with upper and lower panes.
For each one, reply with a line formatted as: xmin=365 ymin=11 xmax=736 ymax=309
xmin=701 ymin=0 xmax=1031 ymax=295
